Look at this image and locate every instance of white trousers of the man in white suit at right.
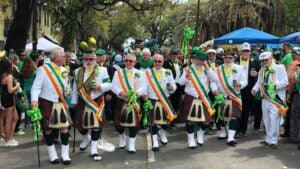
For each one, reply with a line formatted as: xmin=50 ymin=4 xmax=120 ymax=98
xmin=262 ymin=99 xmax=281 ymax=145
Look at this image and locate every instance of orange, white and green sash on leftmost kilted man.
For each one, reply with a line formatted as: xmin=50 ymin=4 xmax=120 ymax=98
xmin=42 ymin=64 xmax=69 ymax=111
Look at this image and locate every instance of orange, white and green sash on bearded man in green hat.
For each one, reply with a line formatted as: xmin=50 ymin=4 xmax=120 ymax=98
xmin=184 ymin=67 xmax=216 ymax=116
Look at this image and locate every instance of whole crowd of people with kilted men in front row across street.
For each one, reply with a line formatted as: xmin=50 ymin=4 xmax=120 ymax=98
xmin=0 ymin=42 xmax=300 ymax=164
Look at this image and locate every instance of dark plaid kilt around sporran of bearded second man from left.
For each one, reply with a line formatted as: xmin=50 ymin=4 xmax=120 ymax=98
xmin=72 ymin=96 xmax=104 ymax=130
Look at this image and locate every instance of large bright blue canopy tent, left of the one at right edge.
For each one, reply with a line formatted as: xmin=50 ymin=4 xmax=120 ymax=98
xmin=214 ymin=27 xmax=280 ymax=45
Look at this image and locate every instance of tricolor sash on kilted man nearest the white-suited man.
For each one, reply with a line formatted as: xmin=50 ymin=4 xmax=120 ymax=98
xmin=216 ymin=65 xmax=242 ymax=110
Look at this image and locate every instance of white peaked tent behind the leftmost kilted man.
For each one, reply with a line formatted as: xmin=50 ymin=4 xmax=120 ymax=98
xmin=25 ymin=37 xmax=62 ymax=52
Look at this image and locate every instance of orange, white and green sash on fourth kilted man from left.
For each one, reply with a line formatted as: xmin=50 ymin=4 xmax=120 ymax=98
xmin=145 ymin=69 xmax=177 ymax=121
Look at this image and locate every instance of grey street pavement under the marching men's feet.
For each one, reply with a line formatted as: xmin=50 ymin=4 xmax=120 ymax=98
xmin=0 ymin=126 xmax=300 ymax=169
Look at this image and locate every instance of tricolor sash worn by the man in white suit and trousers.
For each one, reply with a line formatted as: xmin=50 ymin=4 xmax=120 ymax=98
xmin=260 ymin=68 xmax=289 ymax=115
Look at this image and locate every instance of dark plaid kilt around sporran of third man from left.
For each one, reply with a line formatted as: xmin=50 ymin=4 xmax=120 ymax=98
xmin=114 ymin=98 xmax=142 ymax=127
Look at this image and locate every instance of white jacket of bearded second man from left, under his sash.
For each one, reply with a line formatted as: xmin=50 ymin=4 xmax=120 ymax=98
xmin=71 ymin=66 xmax=111 ymax=104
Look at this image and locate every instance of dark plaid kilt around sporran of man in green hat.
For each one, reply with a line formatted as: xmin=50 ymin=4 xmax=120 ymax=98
xmin=182 ymin=94 xmax=212 ymax=122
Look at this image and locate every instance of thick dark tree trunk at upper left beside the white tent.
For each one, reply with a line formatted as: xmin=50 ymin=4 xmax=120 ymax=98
xmin=5 ymin=0 xmax=36 ymax=53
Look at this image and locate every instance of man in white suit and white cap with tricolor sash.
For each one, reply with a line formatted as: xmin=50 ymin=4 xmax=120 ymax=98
xmin=251 ymin=52 xmax=288 ymax=149
